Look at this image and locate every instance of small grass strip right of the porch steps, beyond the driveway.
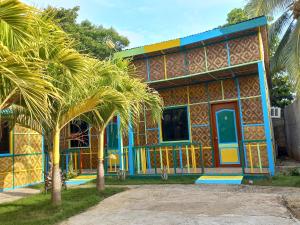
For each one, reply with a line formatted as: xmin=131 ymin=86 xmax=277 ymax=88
xmin=243 ymin=175 xmax=300 ymax=187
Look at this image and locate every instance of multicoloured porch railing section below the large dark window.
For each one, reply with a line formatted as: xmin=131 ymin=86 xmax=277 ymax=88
xmin=133 ymin=143 xmax=204 ymax=175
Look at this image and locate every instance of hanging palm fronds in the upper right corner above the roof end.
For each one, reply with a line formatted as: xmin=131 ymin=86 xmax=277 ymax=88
xmin=245 ymin=0 xmax=300 ymax=94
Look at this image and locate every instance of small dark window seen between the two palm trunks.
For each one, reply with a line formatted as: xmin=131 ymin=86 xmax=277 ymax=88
xmin=70 ymin=120 xmax=90 ymax=148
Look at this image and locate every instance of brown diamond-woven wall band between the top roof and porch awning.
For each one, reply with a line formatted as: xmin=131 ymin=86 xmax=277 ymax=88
xmin=134 ymin=34 xmax=260 ymax=81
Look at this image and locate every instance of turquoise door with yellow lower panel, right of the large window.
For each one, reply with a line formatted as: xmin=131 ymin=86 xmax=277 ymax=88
xmin=215 ymin=109 xmax=240 ymax=165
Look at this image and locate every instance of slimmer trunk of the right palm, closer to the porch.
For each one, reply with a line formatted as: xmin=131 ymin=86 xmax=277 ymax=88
xmin=97 ymin=128 xmax=105 ymax=191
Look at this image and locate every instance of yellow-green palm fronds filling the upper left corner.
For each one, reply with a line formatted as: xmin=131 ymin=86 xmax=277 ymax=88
xmin=0 ymin=0 xmax=57 ymax=122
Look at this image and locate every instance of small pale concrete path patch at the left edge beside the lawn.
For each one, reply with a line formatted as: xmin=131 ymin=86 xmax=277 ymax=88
xmin=0 ymin=188 xmax=40 ymax=204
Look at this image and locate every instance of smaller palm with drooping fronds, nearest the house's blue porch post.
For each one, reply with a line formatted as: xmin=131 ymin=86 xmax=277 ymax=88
xmin=82 ymin=59 xmax=162 ymax=191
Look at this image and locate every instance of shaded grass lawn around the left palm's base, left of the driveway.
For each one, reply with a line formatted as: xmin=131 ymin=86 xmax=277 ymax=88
xmin=0 ymin=187 xmax=125 ymax=225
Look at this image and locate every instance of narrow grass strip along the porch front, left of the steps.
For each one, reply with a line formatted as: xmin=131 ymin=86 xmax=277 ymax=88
xmin=99 ymin=175 xmax=199 ymax=185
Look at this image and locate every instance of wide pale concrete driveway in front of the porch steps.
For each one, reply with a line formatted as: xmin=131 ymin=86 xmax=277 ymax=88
xmin=62 ymin=185 xmax=300 ymax=225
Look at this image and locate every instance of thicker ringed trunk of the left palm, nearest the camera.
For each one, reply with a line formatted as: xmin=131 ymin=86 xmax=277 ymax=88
xmin=52 ymin=128 xmax=61 ymax=206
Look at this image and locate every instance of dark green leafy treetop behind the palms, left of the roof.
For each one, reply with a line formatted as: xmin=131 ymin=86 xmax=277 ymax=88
xmin=44 ymin=6 xmax=129 ymax=59
